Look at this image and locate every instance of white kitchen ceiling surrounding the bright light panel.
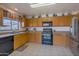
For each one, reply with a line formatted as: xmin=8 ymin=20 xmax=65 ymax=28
xmin=0 ymin=3 xmax=79 ymax=16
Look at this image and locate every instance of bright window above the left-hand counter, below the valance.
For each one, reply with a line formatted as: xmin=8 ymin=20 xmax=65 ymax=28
xmin=0 ymin=17 xmax=22 ymax=31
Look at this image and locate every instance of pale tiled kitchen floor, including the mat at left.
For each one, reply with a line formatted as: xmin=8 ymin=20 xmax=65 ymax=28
xmin=10 ymin=43 xmax=73 ymax=56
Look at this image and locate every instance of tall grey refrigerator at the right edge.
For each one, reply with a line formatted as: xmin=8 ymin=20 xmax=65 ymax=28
xmin=70 ymin=17 xmax=79 ymax=56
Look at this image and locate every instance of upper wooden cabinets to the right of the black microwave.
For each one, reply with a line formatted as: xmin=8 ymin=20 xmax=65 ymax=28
xmin=52 ymin=16 xmax=72 ymax=26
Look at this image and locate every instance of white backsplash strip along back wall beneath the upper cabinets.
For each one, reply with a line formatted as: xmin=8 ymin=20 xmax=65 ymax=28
xmin=26 ymin=27 xmax=71 ymax=31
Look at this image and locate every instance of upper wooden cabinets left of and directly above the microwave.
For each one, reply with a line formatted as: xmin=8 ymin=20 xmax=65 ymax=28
xmin=26 ymin=18 xmax=52 ymax=27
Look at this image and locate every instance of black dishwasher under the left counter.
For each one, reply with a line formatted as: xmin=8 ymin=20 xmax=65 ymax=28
xmin=0 ymin=36 xmax=14 ymax=56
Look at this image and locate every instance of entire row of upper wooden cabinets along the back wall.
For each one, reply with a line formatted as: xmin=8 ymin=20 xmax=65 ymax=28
xmin=27 ymin=15 xmax=72 ymax=27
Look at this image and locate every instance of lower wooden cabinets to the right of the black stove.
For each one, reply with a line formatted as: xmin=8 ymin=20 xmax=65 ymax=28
xmin=53 ymin=32 xmax=70 ymax=47
